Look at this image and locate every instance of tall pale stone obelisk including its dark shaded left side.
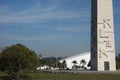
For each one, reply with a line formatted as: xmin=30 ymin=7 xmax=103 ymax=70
xmin=91 ymin=0 xmax=116 ymax=71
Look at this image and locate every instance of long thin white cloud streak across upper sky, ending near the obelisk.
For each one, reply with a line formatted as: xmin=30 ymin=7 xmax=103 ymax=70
xmin=0 ymin=12 xmax=88 ymax=23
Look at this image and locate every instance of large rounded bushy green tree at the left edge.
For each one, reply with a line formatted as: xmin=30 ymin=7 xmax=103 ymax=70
xmin=0 ymin=44 xmax=38 ymax=80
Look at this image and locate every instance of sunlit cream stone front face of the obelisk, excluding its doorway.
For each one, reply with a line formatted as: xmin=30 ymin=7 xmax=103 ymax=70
xmin=92 ymin=0 xmax=116 ymax=71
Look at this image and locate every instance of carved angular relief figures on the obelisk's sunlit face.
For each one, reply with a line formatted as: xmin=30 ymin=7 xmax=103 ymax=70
xmin=98 ymin=19 xmax=113 ymax=58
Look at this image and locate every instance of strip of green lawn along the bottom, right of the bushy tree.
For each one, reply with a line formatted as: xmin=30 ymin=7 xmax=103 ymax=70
xmin=29 ymin=73 xmax=120 ymax=80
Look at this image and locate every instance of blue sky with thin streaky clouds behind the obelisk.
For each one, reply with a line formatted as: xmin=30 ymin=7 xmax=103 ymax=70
xmin=0 ymin=0 xmax=120 ymax=57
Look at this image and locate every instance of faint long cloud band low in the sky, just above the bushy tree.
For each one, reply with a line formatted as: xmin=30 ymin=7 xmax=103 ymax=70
xmin=0 ymin=33 xmax=67 ymax=41
